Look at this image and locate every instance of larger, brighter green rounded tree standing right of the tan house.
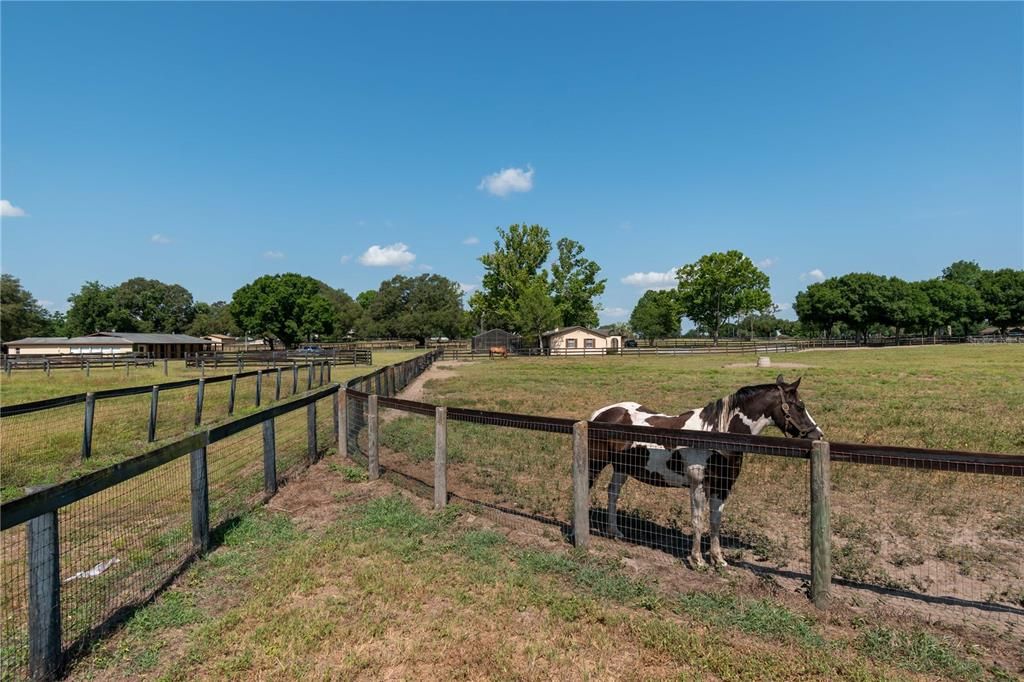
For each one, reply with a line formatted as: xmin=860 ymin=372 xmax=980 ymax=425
xmin=676 ymin=250 xmax=771 ymax=345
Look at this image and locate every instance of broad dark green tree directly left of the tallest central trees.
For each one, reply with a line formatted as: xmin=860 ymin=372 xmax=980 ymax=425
xmin=361 ymin=274 xmax=464 ymax=343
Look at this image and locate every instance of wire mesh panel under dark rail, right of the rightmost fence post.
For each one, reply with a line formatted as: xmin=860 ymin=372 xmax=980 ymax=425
xmin=831 ymin=456 xmax=1024 ymax=626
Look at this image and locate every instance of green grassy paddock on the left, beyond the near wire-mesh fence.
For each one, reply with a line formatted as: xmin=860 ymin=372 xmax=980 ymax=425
xmin=0 ymin=351 xmax=419 ymax=500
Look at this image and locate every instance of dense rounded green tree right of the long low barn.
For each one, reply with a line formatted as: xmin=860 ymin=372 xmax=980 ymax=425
xmin=230 ymin=272 xmax=338 ymax=348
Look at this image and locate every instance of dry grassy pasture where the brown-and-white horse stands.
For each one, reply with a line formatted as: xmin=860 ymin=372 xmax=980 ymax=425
xmin=381 ymin=346 xmax=1024 ymax=629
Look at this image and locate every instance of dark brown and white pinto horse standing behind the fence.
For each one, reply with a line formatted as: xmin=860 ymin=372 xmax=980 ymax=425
xmin=589 ymin=375 xmax=824 ymax=567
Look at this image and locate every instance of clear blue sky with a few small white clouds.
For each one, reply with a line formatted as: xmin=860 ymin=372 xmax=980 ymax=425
xmin=0 ymin=2 xmax=1024 ymax=322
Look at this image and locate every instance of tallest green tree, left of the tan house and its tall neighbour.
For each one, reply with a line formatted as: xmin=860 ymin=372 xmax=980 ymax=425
xmin=470 ymin=224 xmax=551 ymax=331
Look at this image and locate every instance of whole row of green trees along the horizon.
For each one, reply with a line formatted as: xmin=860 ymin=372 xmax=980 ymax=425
xmin=0 ymin=224 xmax=1024 ymax=346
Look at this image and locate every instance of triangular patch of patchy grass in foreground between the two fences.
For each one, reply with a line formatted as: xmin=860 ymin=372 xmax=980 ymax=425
xmin=69 ymin=457 xmax=1013 ymax=680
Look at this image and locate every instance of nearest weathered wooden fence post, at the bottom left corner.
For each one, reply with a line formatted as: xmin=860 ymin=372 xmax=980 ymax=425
xmin=26 ymin=485 xmax=61 ymax=680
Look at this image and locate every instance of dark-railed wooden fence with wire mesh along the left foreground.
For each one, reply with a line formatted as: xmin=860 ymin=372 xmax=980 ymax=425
xmin=0 ymin=353 xmax=436 ymax=679
